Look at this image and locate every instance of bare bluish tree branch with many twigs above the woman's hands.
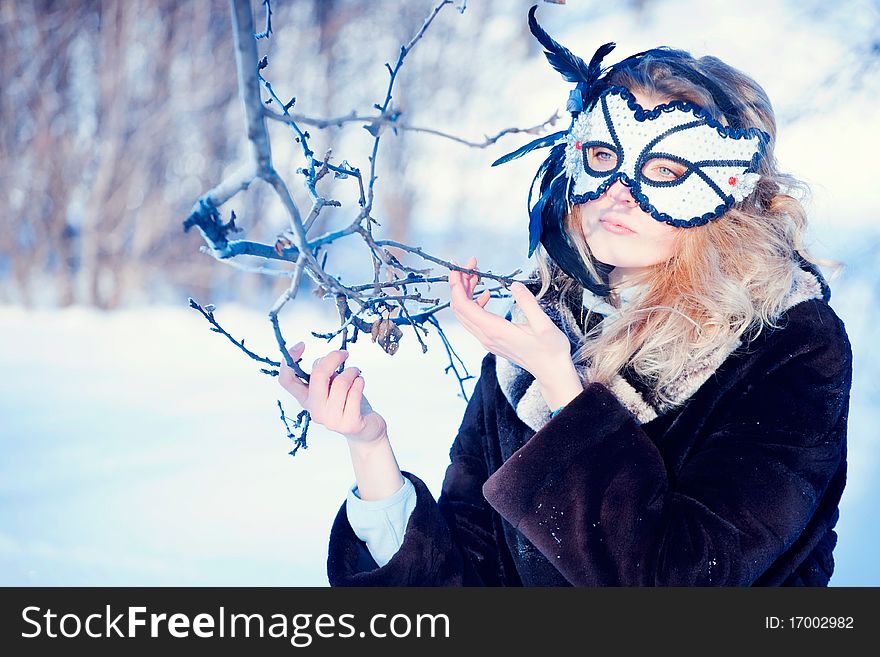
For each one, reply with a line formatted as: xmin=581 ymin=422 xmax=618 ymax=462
xmin=183 ymin=0 xmax=558 ymax=454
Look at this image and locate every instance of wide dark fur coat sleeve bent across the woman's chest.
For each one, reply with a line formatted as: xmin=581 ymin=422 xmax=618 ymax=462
xmin=483 ymin=308 xmax=852 ymax=586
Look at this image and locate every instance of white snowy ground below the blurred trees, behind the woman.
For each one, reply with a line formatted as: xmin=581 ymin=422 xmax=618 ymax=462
xmin=0 ymin=288 xmax=880 ymax=586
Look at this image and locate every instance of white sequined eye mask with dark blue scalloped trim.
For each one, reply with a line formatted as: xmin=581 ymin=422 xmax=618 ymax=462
xmin=565 ymin=87 xmax=769 ymax=227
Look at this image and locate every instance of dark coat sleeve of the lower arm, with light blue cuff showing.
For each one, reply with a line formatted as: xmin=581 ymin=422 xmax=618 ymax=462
xmin=327 ymin=354 xmax=501 ymax=586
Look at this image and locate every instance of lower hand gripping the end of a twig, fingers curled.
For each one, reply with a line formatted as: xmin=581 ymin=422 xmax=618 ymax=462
xmin=278 ymin=342 xmax=388 ymax=445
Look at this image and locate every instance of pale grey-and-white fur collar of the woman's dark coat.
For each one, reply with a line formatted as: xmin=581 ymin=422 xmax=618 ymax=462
xmin=495 ymin=260 xmax=831 ymax=432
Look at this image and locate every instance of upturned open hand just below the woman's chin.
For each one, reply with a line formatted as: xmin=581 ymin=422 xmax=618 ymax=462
xmin=448 ymin=257 xmax=574 ymax=382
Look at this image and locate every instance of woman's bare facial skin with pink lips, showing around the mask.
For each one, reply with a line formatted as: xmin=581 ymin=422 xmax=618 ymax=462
xmin=574 ymin=92 xmax=686 ymax=280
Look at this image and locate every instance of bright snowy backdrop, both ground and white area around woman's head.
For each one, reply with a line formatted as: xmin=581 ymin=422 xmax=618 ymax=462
xmin=0 ymin=0 xmax=880 ymax=586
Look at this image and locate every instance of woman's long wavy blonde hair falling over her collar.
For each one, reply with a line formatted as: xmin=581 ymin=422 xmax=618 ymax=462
xmin=534 ymin=51 xmax=843 ymax=405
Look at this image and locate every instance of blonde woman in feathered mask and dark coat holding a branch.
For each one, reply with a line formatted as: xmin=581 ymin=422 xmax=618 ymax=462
xmin=279 ymin=7 xmax=852 ymax=586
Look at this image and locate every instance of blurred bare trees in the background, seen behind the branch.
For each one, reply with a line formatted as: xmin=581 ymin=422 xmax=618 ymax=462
xmin=0 ymin=0 xmax=880 ymax=308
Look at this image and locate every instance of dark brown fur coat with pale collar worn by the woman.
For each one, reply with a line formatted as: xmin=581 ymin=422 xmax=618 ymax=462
xmin=327 ymin=264 xmax=852 ymax=586
